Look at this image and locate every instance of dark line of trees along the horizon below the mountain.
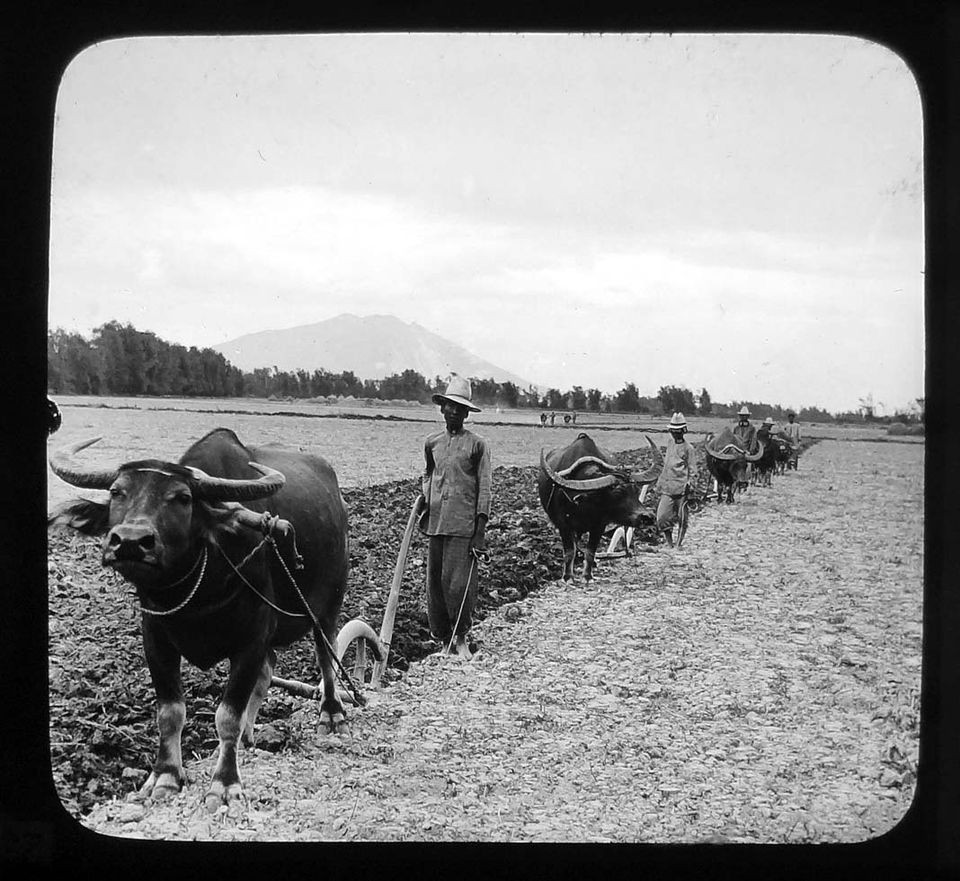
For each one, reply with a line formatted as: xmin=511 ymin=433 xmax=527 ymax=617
xmin=47 ymin=321 xmax=923 ymax=423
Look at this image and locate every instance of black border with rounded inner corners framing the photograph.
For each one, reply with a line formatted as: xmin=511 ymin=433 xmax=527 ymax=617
xmin=0 ymin=0 xmax=960 ymax=878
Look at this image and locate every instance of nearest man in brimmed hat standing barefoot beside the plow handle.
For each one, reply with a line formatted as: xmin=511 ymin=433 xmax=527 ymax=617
xmin=421 ymin=374 xmax=491 ymax=658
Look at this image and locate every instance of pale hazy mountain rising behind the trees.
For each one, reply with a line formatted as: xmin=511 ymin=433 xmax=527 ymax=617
xmin=210 ymin=314 xmax=531 ymax=389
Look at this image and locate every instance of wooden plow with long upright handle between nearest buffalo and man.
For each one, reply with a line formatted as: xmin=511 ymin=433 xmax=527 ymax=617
xmin=270 ymin=496 xmax=421 ymax=706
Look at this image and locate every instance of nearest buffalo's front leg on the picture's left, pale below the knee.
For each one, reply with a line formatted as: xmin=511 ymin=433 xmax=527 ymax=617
xmin=140 ymin=616 xmax=187 ymax=798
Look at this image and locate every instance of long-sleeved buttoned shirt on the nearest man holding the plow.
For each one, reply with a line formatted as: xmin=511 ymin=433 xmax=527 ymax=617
xmin=422 ymin=429 xmax=492 ymax=537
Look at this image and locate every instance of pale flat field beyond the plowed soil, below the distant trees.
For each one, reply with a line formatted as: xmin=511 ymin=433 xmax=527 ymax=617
xmin=47 ymin=396 xmax=900 ymax=505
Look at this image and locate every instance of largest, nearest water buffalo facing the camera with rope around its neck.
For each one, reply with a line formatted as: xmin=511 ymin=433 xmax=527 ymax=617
xmin=50 ymin=428 xmax=379 ymax=810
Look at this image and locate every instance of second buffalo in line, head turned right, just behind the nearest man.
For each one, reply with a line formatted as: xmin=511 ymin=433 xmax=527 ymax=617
xmin=538 ymin=432 xmax=663 ymax=581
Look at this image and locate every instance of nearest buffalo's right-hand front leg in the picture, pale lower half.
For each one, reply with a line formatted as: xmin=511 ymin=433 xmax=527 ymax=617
xmin=205 ymin=646 xmax=268 ymax=810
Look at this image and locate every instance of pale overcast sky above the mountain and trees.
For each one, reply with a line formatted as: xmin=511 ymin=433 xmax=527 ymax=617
xmin=49 ymin=34 xmax=924 ymax=412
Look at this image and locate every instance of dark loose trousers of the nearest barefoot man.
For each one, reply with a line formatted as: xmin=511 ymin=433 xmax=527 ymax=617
xmin=427 ymin=535 xmax=478 ymax=642
